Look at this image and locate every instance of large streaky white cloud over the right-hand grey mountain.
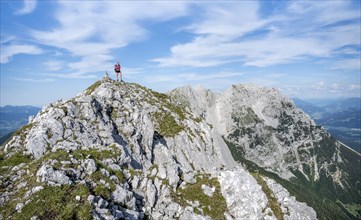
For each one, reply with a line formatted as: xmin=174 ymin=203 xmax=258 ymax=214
xmin=152 ymin=1 xmax=360 ymax=67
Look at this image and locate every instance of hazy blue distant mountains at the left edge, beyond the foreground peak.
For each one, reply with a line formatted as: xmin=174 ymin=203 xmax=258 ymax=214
xmin=0 ymin=105 xmax=40 ymax=144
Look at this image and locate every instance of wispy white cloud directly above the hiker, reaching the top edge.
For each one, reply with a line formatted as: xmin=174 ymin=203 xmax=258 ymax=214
xmin=32 ymin=1 xmax=188 ymax=73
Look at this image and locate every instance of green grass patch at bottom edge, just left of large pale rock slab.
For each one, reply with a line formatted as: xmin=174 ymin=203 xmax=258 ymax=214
xmin=173 ymin=175 xmax=227 ymax=219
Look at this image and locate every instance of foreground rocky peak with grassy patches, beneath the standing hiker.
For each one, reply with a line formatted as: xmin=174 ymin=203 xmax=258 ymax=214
xmin=0 ymin=77 xmax=316 ymax=219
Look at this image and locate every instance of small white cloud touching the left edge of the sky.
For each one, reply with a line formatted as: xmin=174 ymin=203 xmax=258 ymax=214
xmin=0 ymin=44 xmax=43 ymax=63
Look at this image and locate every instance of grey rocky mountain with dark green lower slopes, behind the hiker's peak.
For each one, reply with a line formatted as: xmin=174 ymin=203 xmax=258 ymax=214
xmin=169 ymin=84 xmax=361 ymax=219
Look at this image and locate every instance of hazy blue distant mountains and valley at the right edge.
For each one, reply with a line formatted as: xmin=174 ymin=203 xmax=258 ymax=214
xmin=293 ymin=98 xmax=361 ymax=152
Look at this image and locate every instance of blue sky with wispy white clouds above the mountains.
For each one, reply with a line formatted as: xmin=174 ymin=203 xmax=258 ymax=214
xmin=0 ymin=0 xmax=361 ymax=106
